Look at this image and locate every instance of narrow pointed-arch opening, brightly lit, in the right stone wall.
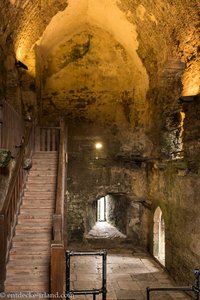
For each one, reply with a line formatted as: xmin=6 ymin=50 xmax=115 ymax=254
xmin=153 ymin=206 xmax=165 ymax=265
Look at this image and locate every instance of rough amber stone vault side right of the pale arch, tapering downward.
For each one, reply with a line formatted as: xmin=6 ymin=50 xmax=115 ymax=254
xmin=118 ymin=0 xmax=200 ymax=157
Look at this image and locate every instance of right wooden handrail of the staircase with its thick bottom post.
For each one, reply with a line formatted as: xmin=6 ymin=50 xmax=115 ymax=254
xmin=51 ymin=120 xmax=66 ymax=299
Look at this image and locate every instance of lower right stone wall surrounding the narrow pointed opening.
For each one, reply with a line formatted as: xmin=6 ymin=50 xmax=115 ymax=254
xmin=147 ymin=96 xmax=200 ymax=284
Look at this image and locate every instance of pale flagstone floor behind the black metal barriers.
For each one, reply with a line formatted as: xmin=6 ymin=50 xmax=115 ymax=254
xmin=67 ymin=249 xmax=194 ymax=300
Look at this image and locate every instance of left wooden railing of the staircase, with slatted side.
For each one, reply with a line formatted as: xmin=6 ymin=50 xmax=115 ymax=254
xmin=0 ymin=123 xmax=33 ymax=292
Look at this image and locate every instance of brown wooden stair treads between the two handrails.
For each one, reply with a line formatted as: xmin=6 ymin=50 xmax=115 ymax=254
xmin=5 ymin=151 xmax=57 ymax=293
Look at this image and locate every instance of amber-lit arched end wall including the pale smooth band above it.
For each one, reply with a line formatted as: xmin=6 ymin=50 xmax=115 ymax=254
xmin=38 ymin=0 xmax=148 ymax=126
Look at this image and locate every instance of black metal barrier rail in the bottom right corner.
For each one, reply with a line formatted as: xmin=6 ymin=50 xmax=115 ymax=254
xmin=146 ymin=269 xmax=200 ymax=300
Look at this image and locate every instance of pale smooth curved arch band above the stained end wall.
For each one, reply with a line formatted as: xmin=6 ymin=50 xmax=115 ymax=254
xmin=39 ymin=0 xmax=148 ymax=99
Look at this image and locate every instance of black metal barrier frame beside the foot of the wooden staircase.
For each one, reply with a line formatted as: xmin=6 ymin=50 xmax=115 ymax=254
xmin=66 ymin=250 xmax=107 ymax=300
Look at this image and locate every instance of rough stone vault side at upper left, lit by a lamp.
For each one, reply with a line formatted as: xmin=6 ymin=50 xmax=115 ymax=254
xmin=0 ymin=0 xmax=67 ymax=114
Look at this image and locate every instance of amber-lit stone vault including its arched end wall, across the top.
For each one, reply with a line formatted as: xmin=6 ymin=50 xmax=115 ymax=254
xmin=0 ymin=0 xmax=200 ymax=158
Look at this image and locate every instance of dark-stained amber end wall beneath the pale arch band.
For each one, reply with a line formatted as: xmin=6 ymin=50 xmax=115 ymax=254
xmin=40 ymin=26 xmax=144 ymax=126
